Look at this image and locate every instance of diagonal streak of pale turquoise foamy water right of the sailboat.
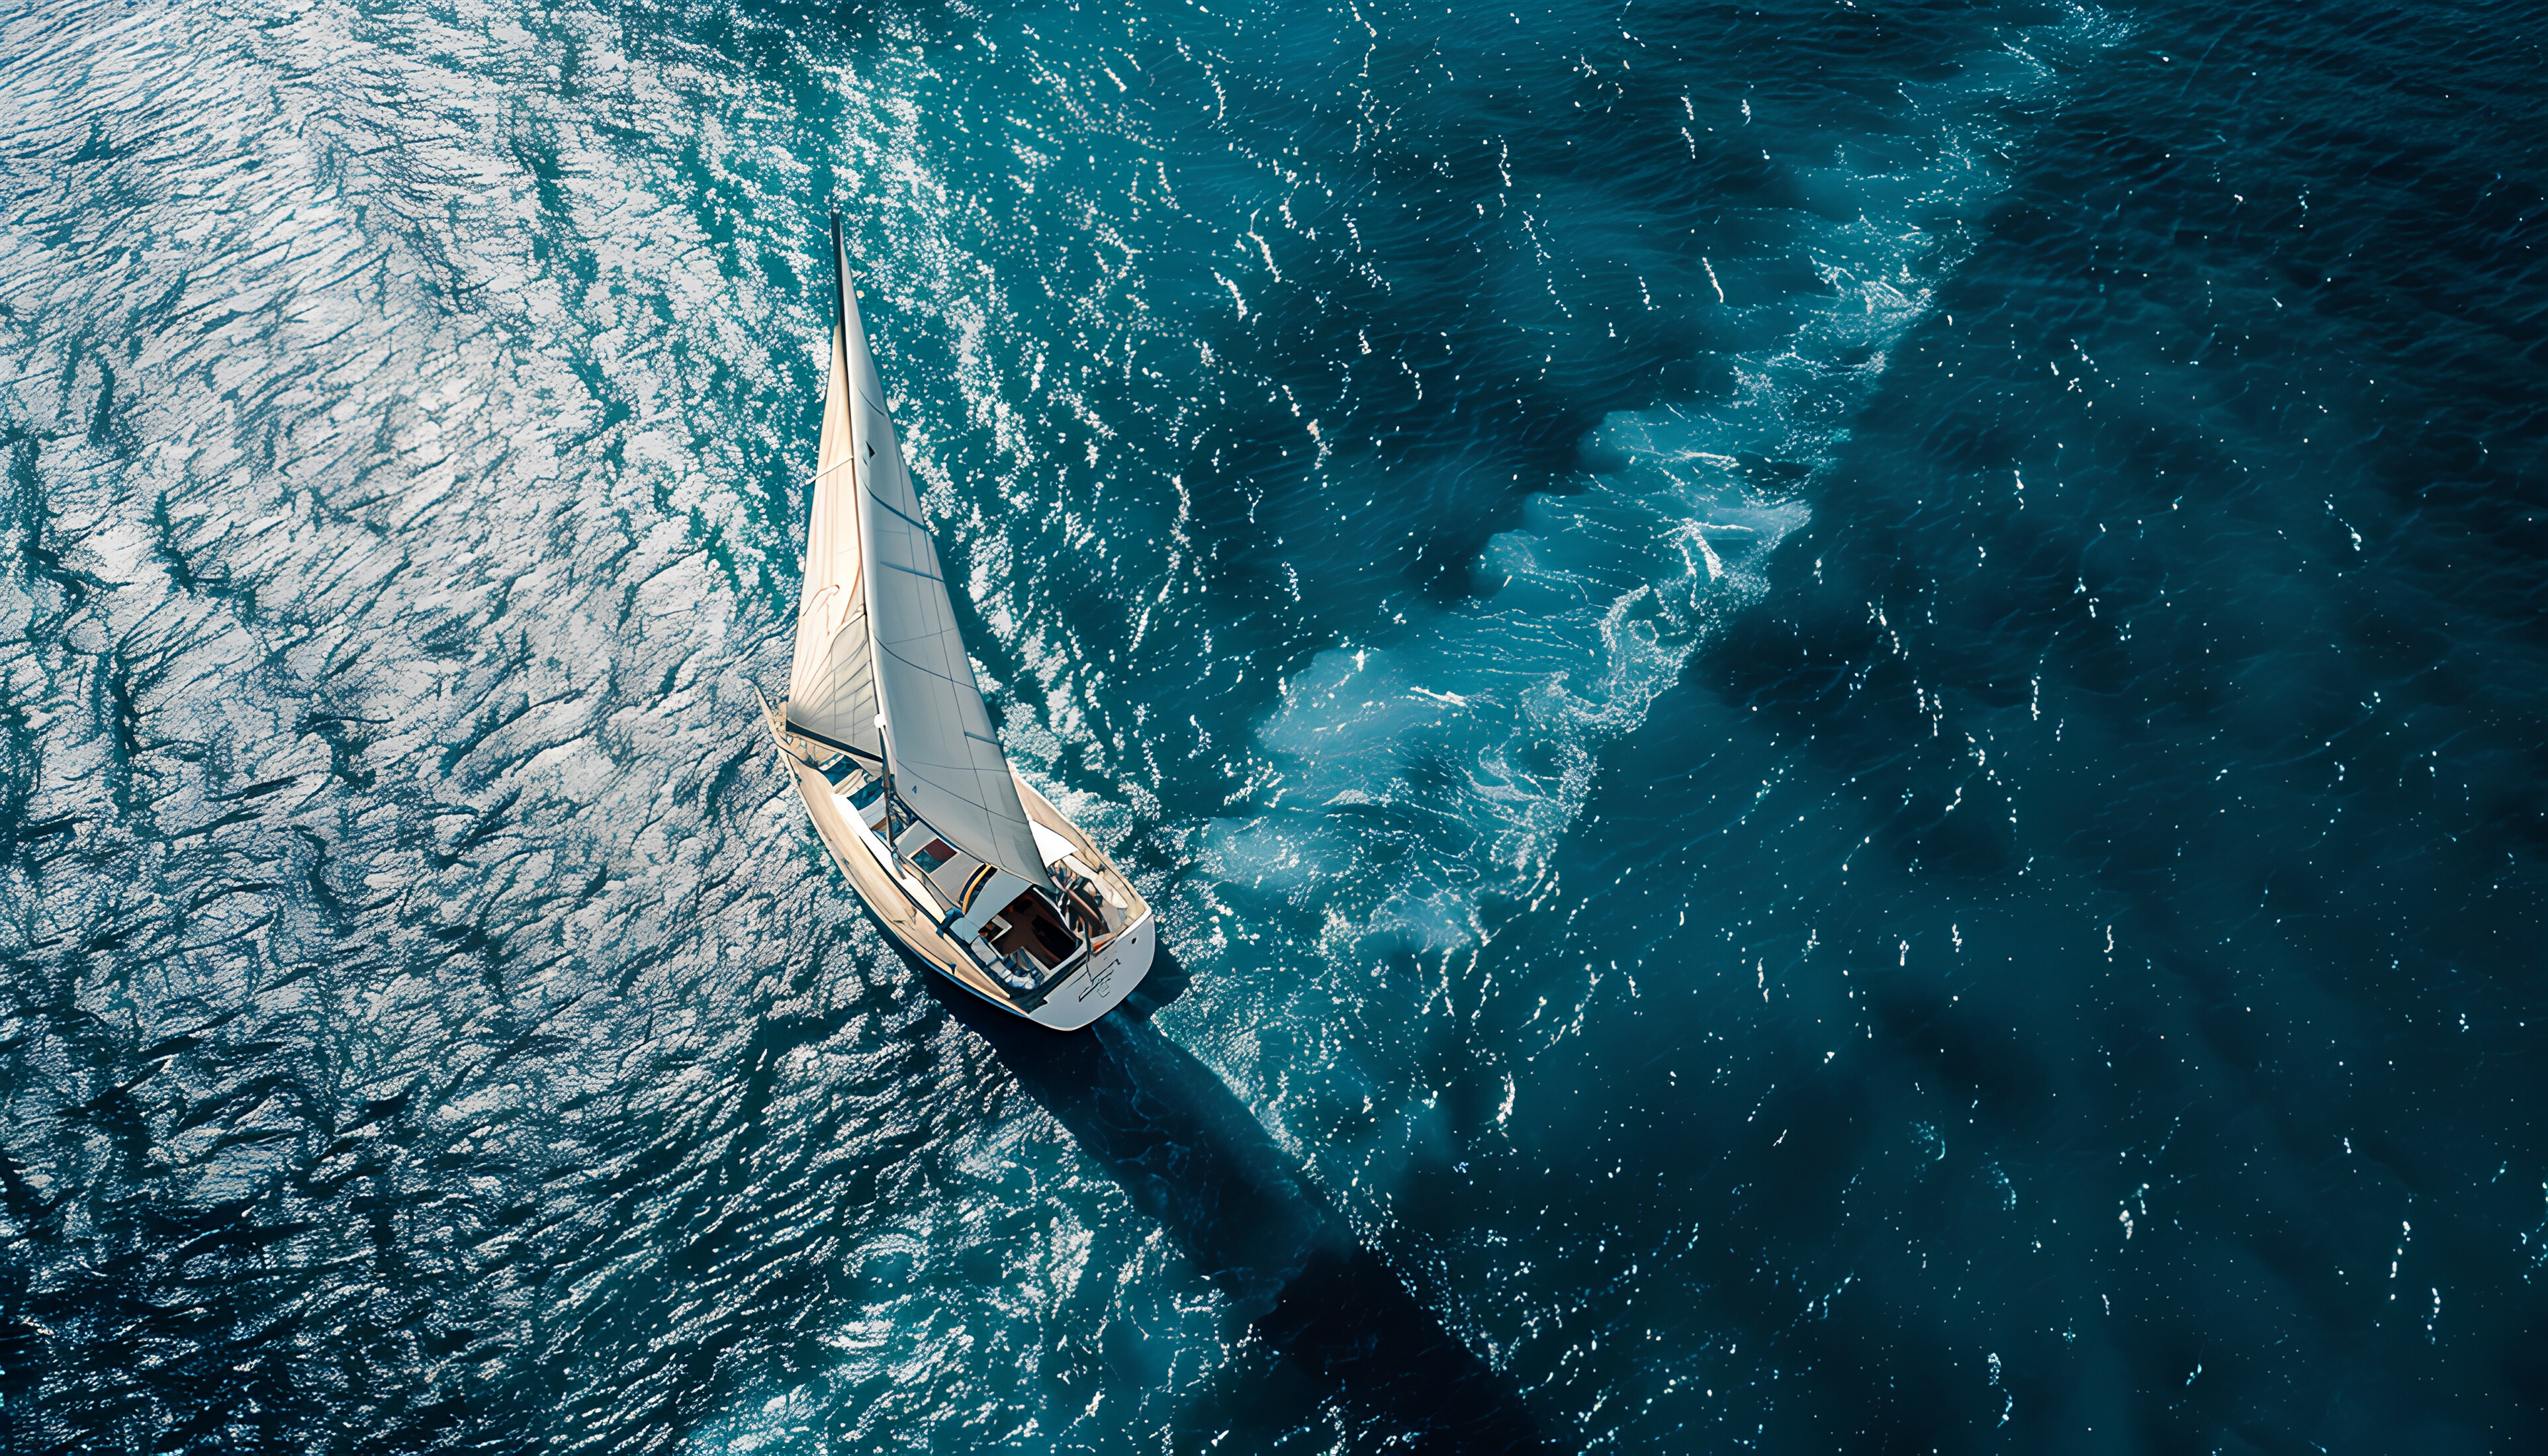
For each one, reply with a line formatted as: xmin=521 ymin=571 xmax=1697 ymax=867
xmin=1180 ymin=10 xmax=2117 ymax=1229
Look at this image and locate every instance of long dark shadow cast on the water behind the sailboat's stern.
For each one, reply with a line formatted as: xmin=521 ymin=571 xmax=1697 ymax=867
xmin=927 ymin=948 xmax=1555 ymax=1451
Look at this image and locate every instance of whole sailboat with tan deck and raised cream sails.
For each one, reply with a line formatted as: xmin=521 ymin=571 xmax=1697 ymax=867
xmin=762 ymin=214 xmax=1160 ymax=1030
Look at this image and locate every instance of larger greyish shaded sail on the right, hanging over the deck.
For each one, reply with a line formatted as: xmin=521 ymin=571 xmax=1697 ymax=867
xmin=807 ymin=222 xmax=1055 ymax=910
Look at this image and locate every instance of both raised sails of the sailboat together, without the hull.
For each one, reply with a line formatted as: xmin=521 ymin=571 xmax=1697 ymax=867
xmin=788 ymin=219 xmax=1058 ymax=913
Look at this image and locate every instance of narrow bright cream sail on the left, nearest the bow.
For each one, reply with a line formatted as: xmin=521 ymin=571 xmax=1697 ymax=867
xmin=788 ymin=227 xmax=884 ymax=768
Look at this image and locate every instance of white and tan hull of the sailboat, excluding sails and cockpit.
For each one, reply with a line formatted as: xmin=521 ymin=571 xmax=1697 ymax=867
xmin=772 ymin=714 xmax=1160 ymax=1030
